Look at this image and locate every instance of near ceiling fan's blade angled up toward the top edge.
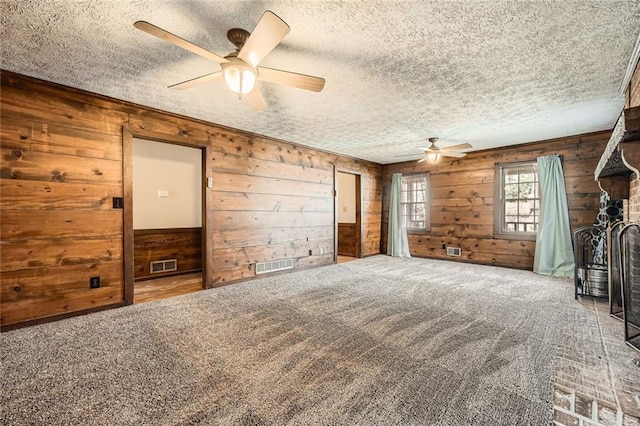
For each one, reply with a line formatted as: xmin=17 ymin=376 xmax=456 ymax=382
xmin=238 ymin=10 xmax=290 ymax=67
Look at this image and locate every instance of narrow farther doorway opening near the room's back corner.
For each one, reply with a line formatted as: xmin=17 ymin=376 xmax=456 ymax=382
xmin=335 ymin=170 xmax=362 ymax=263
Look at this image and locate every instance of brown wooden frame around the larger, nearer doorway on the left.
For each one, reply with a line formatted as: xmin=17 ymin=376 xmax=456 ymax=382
xmin=122 ymin=126 xmax=213 ymax=305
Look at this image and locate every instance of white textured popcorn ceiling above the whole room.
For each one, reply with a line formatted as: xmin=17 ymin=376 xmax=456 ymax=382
xmin=0 ymin=0 xmax=640 ymax=163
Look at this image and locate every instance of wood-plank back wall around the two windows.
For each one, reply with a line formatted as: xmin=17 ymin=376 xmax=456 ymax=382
xmin=382 ymin=132 xmax=611 ymax=269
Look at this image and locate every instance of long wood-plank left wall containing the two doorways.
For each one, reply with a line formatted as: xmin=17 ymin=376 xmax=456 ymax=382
xmin=0 ymin=71 xmax=382 ymax=325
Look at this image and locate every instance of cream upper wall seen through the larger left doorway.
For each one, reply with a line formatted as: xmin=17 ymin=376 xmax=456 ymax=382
xmin=133 ymin=138 xmax=202 ymax=229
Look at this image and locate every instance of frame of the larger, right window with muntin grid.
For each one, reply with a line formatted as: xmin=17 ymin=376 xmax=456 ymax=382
xmin=494 ymin=160 xmax=540 ymax=240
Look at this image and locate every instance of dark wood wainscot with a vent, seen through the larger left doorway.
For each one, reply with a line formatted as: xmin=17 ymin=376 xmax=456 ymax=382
xmin=133 ymin=228 xmax=202 ymax=279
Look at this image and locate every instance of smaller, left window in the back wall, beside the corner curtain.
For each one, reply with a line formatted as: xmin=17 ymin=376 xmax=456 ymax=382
xmin=400 ymin=174 xmax=429 ymax=231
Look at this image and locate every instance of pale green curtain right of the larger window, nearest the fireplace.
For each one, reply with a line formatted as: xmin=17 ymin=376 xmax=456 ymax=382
xmin=533 ymin=155 xmax=575 ymax=277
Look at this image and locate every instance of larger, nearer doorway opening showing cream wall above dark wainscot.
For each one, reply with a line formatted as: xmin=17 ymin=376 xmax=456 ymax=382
xmin=125 ymin=137 xmax=206 ymax=303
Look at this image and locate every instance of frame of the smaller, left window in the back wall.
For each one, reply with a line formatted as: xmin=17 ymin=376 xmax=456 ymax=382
xmin=400 ymin=173 xmax=431 ymax=233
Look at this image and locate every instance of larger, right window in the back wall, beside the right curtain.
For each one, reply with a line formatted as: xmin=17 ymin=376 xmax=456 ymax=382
xmin=496 ymin=161 xmax=540 ymax=237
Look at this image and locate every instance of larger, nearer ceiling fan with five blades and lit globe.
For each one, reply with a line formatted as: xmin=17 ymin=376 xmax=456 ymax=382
xmin=133 ymin=10 xmax=325 ymax=110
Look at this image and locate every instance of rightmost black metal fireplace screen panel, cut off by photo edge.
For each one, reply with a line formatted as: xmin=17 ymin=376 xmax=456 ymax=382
xmin=619 ymin=223 xmax=640 ymax=350
